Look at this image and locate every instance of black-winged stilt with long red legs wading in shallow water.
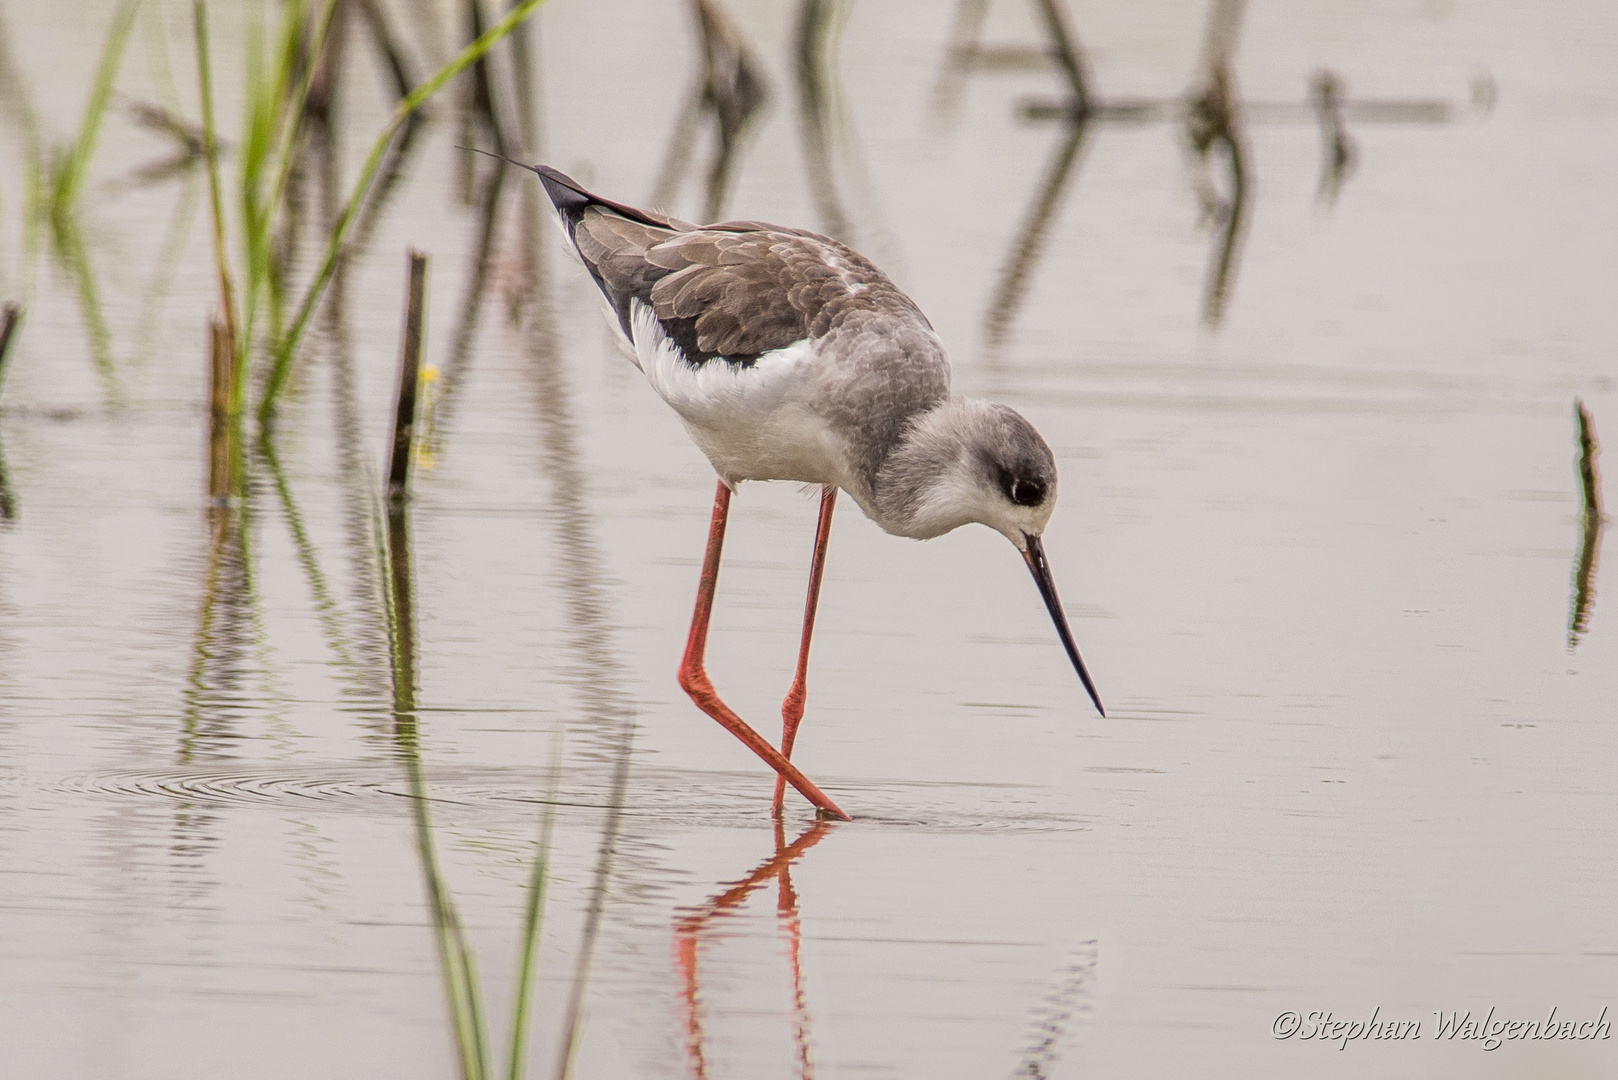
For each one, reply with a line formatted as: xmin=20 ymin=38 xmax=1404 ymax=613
xmin=491 ymin=159 xmax=1105 ymax=819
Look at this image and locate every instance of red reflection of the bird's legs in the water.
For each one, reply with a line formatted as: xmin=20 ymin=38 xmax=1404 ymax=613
xmin=675 ymin=818 xmax=833 ymax=1080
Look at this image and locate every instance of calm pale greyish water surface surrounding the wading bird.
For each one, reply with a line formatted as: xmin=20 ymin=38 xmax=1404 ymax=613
xmin=0 ymin=0 xmax=1618 ymax=1078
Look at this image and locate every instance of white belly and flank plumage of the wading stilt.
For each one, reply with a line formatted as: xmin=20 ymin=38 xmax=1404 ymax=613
xmin=631 ymin=300 xmax=848 ymax=487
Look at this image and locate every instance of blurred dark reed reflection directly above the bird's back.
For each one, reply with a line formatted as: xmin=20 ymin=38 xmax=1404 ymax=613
xmin=649 ymin=0 xmax=770 ymax=222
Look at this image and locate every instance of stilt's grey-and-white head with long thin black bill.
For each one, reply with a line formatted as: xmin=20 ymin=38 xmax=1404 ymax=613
xmin=879 ymin=397 xmax=1105 ymax=716
